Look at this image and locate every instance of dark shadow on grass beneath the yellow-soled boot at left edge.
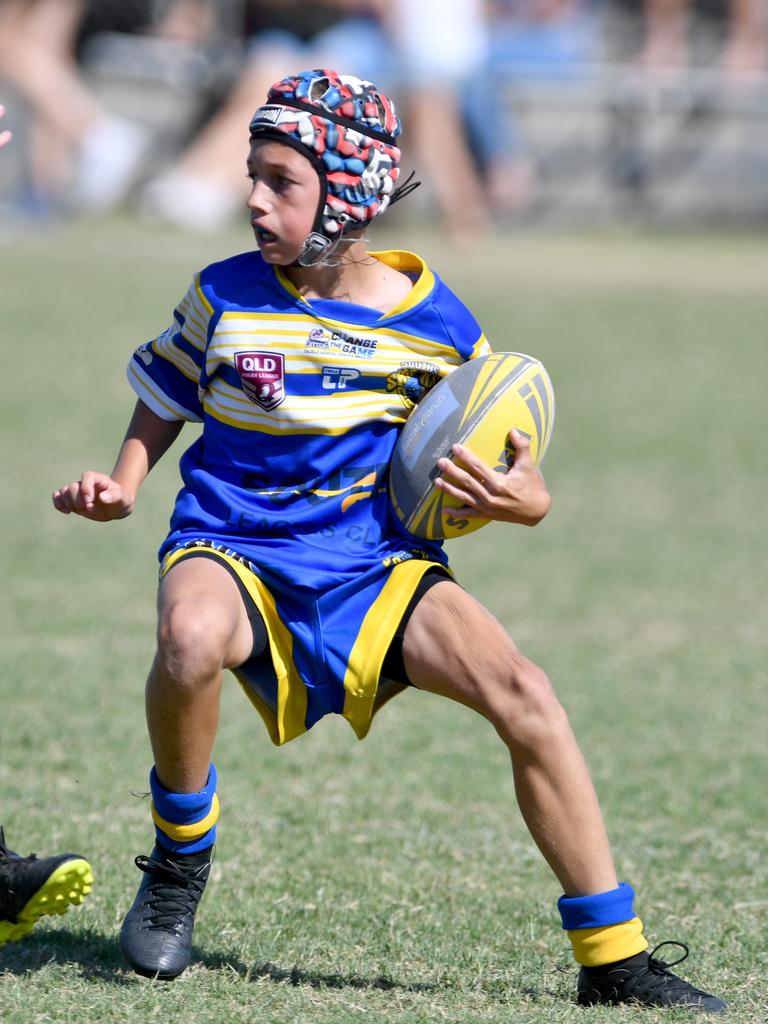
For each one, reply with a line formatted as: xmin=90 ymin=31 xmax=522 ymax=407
xmin=0 ymin=925 xmax=133 ymax=985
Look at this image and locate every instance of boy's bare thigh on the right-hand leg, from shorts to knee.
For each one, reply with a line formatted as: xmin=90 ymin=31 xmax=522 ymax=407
xmin=402 ymin=581 xmax=525 ymax=713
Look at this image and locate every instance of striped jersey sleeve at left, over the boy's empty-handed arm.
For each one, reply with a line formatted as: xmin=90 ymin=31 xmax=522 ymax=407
xmin=128 ymin=275 xmax=213 ymax=423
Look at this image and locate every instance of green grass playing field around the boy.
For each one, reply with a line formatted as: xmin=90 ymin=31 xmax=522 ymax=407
xmin=0 ymin=222 xmax=768 ymax=1024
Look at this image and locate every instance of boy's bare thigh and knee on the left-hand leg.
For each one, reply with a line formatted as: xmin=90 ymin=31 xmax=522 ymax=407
xmin=158 ymin=555 xmax=254 ymax=668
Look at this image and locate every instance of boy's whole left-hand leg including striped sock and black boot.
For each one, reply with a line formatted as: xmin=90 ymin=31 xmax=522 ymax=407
xmin=120 ymin=558 xmax=253 ymax=979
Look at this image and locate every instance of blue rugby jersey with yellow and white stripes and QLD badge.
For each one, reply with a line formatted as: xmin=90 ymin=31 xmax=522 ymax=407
xmin=128 ymin=252 xmax=488 ymax=588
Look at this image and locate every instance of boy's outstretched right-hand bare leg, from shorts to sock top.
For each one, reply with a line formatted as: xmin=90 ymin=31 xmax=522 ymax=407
xmin=402 ymin=582 xmax=618 ymax=896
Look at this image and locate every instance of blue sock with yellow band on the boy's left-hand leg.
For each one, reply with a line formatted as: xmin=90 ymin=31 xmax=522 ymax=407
xmin=150 ymin=765 xmax=219 ymax=854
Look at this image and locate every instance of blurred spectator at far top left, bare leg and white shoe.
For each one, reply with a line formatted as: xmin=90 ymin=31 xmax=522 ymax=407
xmin=0 ymin=0 xmax=221 ymax=213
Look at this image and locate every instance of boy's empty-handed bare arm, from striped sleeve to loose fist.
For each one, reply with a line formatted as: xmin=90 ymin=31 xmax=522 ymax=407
xmin=53 ymin=399 xmax=183 ymax=522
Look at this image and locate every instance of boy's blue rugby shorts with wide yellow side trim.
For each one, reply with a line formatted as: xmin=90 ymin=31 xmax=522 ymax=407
xmin=161 ymin=541 xmax=453 ymax=744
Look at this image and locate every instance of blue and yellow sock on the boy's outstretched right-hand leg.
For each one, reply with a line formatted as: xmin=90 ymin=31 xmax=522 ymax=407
xmin=557 ymin=882 xmax=648 ymax=967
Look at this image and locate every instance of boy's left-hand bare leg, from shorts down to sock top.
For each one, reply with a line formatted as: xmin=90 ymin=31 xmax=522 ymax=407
xmin=146 ymin=558 xmax=253 ymax=793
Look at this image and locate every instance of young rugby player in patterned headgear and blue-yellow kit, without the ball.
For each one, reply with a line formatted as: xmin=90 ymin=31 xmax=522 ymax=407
xmin=53 ymin=71 xmax=724 ymax=1011
